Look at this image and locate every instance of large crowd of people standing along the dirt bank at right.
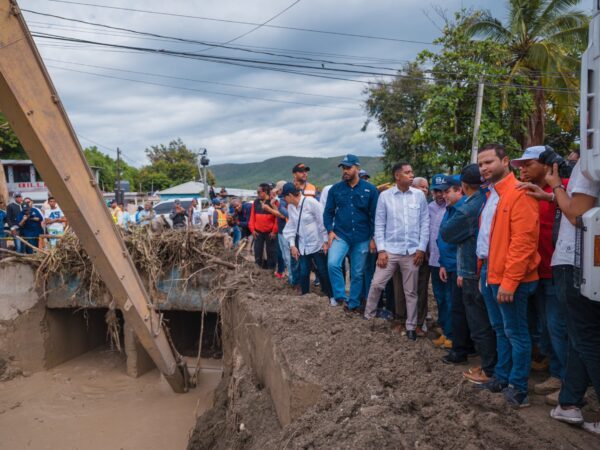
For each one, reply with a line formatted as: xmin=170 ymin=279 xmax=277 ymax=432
xmin=239 ymin=144 xmax=600 ymax=433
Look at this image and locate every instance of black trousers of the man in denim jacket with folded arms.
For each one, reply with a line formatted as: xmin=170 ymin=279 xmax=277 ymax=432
xmin=462 ymin=278 xmax=498 ymax=377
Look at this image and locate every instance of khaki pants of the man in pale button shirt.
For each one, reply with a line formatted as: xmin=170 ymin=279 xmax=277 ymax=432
xmin=365 ymin=253 xmax=419 ymax=330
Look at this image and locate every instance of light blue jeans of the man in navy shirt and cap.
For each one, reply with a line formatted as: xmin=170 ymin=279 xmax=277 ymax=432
xmin=327 ymin=238 xmax=369 ymax=309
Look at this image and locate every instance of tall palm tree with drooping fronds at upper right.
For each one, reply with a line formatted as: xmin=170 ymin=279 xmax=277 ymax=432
xmin=468 ymin=0 xmax=589 ymax=147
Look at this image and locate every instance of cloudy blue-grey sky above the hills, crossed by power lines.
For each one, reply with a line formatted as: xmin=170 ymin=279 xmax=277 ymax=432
xmin=19 ymin=0 xmax=504 ymax=166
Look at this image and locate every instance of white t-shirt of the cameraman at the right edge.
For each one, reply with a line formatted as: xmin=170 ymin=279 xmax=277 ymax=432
xmin=551 ymin=162 xmax=600 ymax=266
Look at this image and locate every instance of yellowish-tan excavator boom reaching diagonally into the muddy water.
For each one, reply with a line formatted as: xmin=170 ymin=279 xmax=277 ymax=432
xmin=0 ymin=0 xmax=185 ymax=392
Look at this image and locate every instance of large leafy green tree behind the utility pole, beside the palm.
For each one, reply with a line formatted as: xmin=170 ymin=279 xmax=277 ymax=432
xmin=412 ymin=10 xmax=532 ymax=172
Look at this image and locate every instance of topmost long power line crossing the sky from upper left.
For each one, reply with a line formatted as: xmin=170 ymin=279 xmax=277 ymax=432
xmin=41 ymin=0 xmax=439 ymax=45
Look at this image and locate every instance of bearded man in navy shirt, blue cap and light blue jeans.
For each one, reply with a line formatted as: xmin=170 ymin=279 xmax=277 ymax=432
xmin=323 ymin=155 xmax=378 ymax=311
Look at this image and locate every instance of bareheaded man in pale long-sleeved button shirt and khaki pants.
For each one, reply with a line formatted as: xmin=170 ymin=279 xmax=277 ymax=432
xmin=365 ymin=163 xmax=429 ymax=341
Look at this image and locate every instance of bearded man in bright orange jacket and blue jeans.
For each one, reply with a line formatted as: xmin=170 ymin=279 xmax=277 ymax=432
xmin=477 ymin=144 xmax=540 ymax=408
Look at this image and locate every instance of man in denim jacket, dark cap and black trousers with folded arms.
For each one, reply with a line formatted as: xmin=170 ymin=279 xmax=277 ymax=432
xmin=440 ymin=164 xmax=497 ymax=384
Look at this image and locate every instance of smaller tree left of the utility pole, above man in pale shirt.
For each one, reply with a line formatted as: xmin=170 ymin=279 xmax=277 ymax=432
xmin=362 ymin=63 xmax=427 ymax=171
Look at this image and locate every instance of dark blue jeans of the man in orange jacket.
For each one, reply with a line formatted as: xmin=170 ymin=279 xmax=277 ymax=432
xmin=481 ymin=264 xmax=537 ymax=392
